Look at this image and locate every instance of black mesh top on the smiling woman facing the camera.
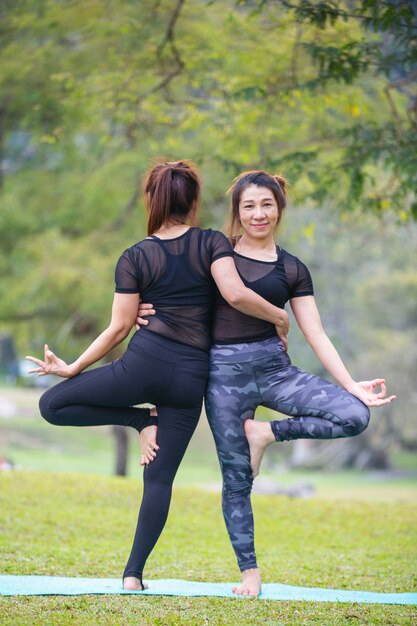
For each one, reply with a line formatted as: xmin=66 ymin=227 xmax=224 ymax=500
xmin=212 ymin=246 xmax=314 ymax=344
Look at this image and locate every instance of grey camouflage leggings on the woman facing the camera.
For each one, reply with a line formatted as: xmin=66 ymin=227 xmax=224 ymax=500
xmin=205 ymin=338 xmax=369 ymax=571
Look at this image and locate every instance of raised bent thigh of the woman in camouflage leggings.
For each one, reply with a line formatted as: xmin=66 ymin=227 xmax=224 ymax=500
xmin=259 ymin=358 xmax=364 ymax=422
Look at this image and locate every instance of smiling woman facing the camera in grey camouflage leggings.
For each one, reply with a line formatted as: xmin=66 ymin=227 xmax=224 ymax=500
xmin=138 ymin=171 xmax=395 ymax=596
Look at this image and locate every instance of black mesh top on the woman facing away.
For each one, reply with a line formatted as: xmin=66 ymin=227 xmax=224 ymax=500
xmin=115 ymin=228 xmax=232 ymax=350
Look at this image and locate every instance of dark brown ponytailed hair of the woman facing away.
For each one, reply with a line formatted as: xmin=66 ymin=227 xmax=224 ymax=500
xmin=143 ymin=160 xmax=201 ymax=235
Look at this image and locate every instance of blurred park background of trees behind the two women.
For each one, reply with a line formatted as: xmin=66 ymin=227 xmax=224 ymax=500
xmin=0 ymin=0 xmax=417 ymax=499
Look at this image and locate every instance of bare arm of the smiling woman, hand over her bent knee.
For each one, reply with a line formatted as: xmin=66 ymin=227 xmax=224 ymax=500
xmin=290 ymin=296 xmax=395 ymax=406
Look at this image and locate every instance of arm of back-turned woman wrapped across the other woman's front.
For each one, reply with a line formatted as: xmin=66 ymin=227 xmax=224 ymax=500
xmin=211 ymin=257 xmax=289 ymax=350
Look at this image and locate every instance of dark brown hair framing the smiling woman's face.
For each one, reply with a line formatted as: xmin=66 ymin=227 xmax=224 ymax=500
xmin=226 ymin=170 xmax=287 ymax=239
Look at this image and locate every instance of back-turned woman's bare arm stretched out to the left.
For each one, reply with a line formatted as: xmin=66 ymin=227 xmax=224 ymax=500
xmin=26 ymin=293 xmax=139 ymax=378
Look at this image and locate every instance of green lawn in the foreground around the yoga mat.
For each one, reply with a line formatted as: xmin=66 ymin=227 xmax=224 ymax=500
xmin=0 ymin=471 xmax=417 ymax=626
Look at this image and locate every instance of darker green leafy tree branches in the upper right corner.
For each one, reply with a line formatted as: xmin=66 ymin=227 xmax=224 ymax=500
xmin=238 ymin=0 xmax=417 ymax=220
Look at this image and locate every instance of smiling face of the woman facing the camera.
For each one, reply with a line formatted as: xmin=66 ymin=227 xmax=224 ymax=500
xmin=239 ymin=185 xmax=278 ymax=239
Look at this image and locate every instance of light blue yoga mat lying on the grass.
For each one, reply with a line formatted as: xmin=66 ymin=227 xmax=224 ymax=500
xmin=0 ymin=575 xmax=417 ymax=604
